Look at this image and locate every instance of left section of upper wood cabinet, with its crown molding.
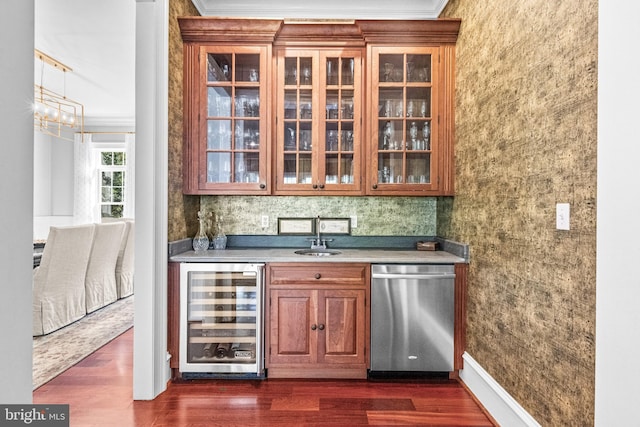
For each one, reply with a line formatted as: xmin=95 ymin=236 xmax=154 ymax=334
xmin=179 ymin=18 xmax=280 ymax=194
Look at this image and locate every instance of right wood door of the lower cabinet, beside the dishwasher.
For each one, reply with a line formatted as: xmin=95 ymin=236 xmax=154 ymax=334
xmin=318 ymin=289 xmax=366 ymax=364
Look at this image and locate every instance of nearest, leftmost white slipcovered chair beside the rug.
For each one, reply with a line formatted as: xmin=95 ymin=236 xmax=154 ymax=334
xmin=33 ymin=224 xmax=95 ymax=336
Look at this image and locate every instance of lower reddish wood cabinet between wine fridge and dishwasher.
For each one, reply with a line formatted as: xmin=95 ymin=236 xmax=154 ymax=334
xmin=265 ymin=263 xmax=370 ymax=378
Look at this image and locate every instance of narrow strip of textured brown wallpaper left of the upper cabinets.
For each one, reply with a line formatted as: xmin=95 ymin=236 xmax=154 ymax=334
xmin=167 ymin=0 xmax=200 ymax=241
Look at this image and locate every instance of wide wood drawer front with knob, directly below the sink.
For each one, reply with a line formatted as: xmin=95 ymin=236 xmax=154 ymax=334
xmin=268 ymin=263 xmax=369 ymax=285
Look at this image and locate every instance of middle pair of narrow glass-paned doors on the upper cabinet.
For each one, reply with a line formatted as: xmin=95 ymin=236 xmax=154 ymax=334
xmin=275 ymin=49 xmax=363 ymax=194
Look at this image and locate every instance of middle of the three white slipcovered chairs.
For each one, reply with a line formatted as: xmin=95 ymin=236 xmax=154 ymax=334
xmin=85 ymin=222 xmax=124 ymax=313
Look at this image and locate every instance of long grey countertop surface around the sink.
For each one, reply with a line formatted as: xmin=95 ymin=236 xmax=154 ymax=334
xmin=170 ymin=248 xmax=467 ymax=264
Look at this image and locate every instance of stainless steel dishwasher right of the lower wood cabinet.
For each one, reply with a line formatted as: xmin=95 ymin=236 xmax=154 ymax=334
xmin=371 ymin=264 xmax=455 ymax=374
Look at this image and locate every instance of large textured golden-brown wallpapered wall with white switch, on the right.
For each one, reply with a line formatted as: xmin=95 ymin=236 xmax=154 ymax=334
xmin=438 ymin=0 xmax=598 ymax=426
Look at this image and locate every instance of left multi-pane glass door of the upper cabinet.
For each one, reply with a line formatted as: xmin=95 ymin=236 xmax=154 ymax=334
xmin=201 ymin=47 xmax=267 ymax=190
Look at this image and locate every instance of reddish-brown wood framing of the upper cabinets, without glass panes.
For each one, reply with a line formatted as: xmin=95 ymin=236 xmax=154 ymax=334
xmin=178 ymin=17 xmax=461 ymax=196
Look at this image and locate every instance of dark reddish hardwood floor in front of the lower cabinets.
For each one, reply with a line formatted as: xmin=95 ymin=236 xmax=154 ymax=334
xmin=33 ymin=329 xmax=494 ymax=427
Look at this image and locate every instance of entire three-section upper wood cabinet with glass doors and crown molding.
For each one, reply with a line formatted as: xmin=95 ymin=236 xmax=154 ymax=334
xmin=179 ymin=17 xmax=460 ymax=196
